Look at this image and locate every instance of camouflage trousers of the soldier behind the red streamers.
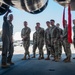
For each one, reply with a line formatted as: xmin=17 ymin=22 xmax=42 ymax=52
xmin=63 ymin=38 xmax=71 ymax=57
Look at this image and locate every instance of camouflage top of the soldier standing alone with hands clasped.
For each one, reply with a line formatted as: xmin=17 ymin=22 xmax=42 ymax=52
xmin=21 ymin=27 xmax=31 ymax=41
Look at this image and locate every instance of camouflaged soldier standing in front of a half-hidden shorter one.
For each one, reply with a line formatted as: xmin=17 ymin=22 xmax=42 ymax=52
xmin=36 ymin=23 xmax=44 ymax=60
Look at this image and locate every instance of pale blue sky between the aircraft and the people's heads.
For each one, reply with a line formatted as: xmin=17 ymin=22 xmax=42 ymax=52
xmin=0 ymin=0 xmax=75 ymax=34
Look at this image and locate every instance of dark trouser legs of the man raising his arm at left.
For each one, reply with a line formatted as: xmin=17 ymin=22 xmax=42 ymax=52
xmin=2 ymin=37 xmax=14 ymax=64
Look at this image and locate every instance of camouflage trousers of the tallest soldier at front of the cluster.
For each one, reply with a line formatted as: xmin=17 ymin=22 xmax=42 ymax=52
xmin=51 ymin=38 xmax=59 ymax=57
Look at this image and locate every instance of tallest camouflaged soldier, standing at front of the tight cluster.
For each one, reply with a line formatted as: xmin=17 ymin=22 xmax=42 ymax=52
xmin=50 ymin=20 xmax=59 ymax=62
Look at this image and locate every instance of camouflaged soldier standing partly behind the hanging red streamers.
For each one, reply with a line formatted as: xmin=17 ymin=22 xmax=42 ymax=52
xmin=63 ymin=20 xmax=71 ymax=62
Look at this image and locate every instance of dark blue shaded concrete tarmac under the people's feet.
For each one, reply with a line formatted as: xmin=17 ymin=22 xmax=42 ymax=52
xmin=0 ymin=44 xmax=75 ymax=75
